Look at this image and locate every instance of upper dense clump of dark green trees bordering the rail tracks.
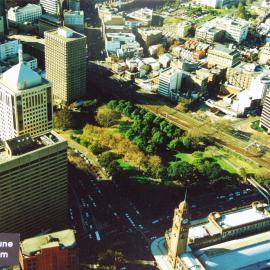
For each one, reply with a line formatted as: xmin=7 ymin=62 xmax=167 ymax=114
xmin=107 ymin=100 xmax=208 ymax=156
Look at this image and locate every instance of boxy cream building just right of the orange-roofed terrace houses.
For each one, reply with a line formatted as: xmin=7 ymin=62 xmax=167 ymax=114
xmin=207 ymin=45 xmax=240 ymax=68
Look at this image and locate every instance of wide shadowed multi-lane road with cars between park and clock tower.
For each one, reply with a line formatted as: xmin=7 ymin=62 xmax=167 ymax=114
xmin=69 ymin=144 xmax=262 ymax=269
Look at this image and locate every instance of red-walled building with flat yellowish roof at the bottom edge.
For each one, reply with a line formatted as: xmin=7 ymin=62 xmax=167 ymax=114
xmin=20 ymin=229 xmax=79 ymax=270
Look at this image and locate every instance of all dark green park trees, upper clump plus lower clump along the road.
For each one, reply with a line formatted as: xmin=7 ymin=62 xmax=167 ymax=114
xmin=107 ymin=100 xmax=238 ymax=187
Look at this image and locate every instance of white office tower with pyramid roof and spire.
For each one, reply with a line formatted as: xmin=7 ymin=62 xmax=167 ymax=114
xmin=0 ymin=45 xmax=52 ymax=140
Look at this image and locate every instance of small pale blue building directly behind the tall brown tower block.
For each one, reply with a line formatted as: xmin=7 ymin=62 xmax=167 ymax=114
xmin=64 ymin=10 xmax=84 ymax=33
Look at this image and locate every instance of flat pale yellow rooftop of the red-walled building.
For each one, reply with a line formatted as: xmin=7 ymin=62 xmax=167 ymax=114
xmin=20 ymin=229 xmax=76 ymax=256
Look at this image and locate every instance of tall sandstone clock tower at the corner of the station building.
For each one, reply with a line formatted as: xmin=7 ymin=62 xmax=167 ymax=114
xmin=167 ymin=194 xmax=190 ymax=268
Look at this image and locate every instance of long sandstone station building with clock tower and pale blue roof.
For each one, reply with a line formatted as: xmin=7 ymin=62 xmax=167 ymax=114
xmin=151 ymin=197 xmax=270 ymax=270
